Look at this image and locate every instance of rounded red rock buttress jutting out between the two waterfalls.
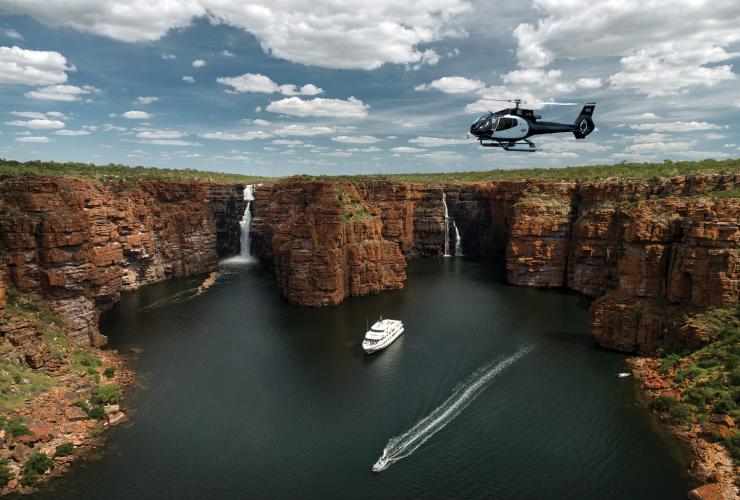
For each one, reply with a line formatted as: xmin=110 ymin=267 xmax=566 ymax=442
xmin=252 ymin=182 xmax=410 ymax=306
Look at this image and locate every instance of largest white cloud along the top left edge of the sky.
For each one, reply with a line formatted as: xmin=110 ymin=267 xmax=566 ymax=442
xmin=3 ymin=0 xmax=471 ymax=70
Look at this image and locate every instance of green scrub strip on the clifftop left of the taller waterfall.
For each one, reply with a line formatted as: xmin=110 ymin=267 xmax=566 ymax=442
xmin=0 ymin=158 xmax=267 ymax=184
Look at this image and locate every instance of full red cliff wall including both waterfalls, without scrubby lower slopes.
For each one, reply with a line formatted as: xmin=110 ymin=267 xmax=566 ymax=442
xmin=0 ymin=165 xmax=740 ymax=496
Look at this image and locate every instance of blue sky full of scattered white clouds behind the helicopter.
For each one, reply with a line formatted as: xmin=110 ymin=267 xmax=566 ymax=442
xmin=0 ymin=0 xmax=740 ymax=176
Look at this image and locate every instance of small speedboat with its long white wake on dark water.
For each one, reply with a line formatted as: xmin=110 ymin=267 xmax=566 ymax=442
xmin=373 ymin=346 xmax=532 ymax=472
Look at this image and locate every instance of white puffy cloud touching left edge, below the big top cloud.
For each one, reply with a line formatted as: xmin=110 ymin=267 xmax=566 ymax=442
xmin=0 ymin=46 xmax=75 ymax=86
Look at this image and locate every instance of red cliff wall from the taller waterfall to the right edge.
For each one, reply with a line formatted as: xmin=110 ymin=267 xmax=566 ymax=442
xmin=252 ymin=175 xmax=740 ymax=353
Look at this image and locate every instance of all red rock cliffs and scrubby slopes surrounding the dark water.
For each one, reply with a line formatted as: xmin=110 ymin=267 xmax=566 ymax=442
xmin=0 ymin=161 xmax=740 ymax=499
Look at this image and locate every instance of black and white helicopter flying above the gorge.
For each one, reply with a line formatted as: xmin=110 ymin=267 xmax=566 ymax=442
xmin=470 ymin=99 xmax=596 ymax=152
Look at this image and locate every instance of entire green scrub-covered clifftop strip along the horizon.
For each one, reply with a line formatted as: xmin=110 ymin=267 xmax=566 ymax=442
xmin=0 ymin=159 xmax=740 ymax=184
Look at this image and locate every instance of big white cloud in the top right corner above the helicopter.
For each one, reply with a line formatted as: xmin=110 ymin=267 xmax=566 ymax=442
xmin=514 ymin=0 xmax=740 ymax=96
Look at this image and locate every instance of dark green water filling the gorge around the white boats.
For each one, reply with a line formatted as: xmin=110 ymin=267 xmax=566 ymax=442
xmin=33 ymin=259 xmax=689 ymax=500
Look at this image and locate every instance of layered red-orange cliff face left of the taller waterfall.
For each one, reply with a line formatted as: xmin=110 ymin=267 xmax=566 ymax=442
xmin=0 ymin=177 xmax=240 ymax=345
